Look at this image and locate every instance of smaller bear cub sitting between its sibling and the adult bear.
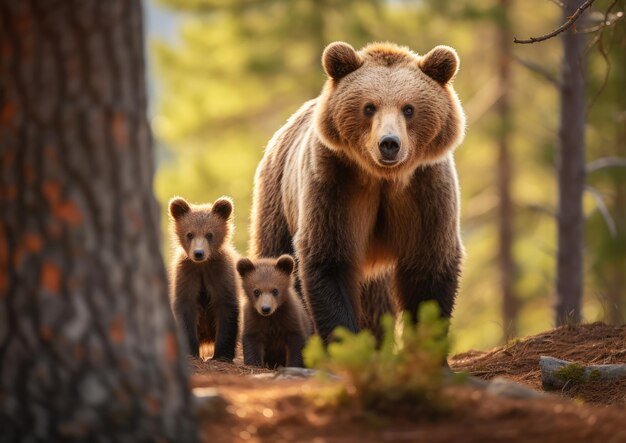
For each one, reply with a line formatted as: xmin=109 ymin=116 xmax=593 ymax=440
xmin=237 ymin=255 xmax=313 ymax=368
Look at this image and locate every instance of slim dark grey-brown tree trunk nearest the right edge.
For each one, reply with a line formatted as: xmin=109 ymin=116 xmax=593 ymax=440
xmin=556 ymin=0 xmax=587 ymax=325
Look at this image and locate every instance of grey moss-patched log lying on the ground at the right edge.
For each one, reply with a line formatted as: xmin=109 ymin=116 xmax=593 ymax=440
xmin=539 ymin=355 xmax=626 ymax=391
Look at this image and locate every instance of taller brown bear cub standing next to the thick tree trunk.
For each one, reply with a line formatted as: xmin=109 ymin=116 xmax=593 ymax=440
xmin=169 ymin=197 xmax=239 ymax=360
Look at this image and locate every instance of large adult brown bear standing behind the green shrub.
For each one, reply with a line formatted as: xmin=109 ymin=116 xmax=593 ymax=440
xmin=250 ymin=42 xmax=465 ymax=341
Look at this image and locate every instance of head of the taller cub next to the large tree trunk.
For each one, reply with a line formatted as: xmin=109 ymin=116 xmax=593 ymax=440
xmin=169 ymin=197 xmax=234 ymax=263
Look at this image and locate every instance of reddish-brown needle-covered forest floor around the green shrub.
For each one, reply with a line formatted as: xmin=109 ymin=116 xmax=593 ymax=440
xmin=191 ymin=324 xmax=626 ymax=443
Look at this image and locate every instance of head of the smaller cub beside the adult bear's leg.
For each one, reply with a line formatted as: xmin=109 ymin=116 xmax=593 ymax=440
xmin=237 ymin=255 xmax=294 ymax=317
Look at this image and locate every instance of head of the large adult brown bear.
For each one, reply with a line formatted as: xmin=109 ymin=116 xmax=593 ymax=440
xmin=315 ymin=42 xmax=465 ymax=179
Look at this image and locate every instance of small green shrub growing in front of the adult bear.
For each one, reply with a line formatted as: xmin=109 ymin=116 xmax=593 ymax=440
xmin=304 ymin=301 xmax=449 ymax=414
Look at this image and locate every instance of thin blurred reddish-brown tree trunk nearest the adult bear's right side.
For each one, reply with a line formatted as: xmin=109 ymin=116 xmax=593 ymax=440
xmin=496 ymin=0 xmax=518 ymax=340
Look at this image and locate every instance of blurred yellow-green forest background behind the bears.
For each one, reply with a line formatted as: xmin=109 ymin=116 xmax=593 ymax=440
xmin=145 ymin=0 xmax=626 ymax=351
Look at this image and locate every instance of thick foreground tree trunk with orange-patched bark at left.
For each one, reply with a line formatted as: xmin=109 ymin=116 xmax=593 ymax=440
xmin=0 ymin=0 xmax=196 ymax=441
